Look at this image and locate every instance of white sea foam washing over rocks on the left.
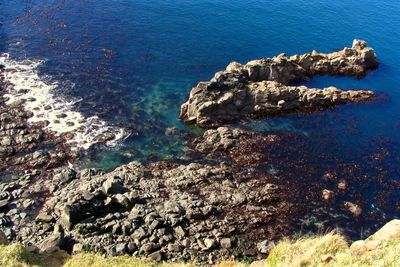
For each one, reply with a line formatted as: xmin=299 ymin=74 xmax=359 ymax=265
xmin=0 ymin=54 xmax=128 ymax=150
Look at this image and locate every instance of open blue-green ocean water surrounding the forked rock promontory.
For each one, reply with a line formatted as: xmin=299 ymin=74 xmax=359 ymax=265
xmin=0 ymin=0 xmax=400 ymax=229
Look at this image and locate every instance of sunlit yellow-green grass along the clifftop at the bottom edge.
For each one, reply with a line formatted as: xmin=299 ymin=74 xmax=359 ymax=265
xmin=0 ymin=233 xmax=400 ymax=267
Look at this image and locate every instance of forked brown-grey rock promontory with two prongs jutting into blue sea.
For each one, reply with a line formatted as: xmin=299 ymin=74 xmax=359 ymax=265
xmin=180 ymin=40 xmax=379 ymax=127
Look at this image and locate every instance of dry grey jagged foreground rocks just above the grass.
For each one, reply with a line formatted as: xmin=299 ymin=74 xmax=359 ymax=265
xmin=17 ymin=127 xmax=280 ymax=262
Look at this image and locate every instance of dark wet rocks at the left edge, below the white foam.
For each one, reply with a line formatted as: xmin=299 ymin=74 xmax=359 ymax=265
xmin=0 ymin=63 xmax=77 ymax=248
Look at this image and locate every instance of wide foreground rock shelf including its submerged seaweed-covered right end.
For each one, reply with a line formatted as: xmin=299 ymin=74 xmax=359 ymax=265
xmin=0 ymin=127 xmax=396 ymax=265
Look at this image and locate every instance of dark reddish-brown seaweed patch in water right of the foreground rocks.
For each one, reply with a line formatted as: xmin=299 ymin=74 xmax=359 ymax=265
xmin=190 ymin=125 xmax=400 ymax=243
